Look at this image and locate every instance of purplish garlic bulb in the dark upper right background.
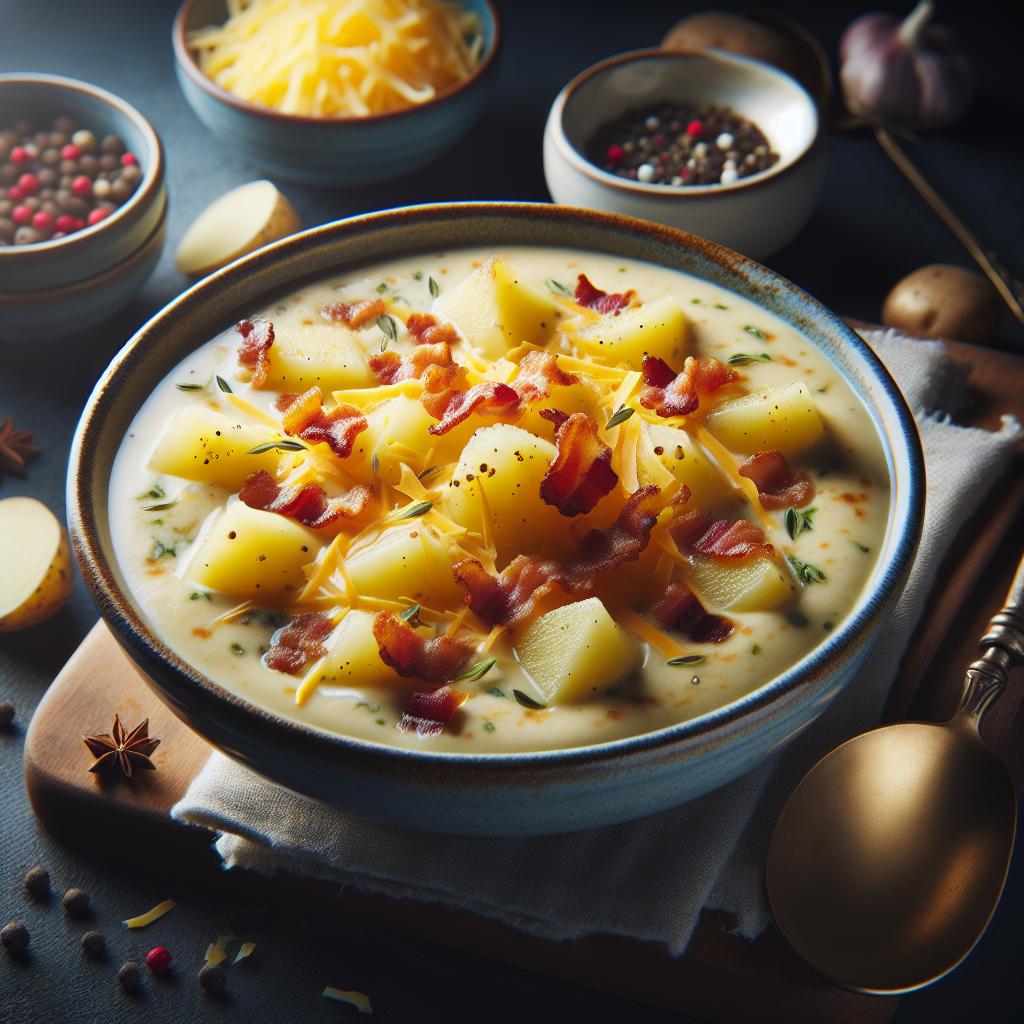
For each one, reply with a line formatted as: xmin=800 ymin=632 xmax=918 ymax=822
xmin=840 ymin=0 xmax=972 ymax=128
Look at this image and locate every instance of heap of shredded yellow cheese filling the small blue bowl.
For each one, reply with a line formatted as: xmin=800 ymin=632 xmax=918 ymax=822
xmin=188 ymin=0 xmax=483 ymax=118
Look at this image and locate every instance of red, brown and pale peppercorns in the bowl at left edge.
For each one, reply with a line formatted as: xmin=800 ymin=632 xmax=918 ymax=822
xmin=0 ymin=117 xmax=142 ymax=246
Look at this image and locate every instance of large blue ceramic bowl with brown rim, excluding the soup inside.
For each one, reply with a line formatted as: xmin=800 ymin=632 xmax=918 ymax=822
xmin=68 ymin=203 xmax=925 ymax=835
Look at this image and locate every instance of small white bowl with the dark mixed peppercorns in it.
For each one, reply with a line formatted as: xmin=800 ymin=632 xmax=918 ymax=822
xmin=544 ymin=50 xmax=824 ymax=259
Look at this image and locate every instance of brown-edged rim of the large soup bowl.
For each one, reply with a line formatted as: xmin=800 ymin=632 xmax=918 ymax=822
xmin=67 ymin=202 xmax=925 ymax=782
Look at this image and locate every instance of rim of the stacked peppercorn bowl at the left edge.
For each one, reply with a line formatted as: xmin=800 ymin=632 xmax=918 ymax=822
xmin=0 ymin=72 xmax=164 ymax=262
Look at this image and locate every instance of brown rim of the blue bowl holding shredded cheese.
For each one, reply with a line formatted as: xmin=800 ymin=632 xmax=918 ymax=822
xmin=171 ymin=0 xmax=502 ymax=126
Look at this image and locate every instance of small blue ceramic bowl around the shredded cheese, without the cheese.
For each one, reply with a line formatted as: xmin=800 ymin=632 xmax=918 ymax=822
xmin=172 ymin=0 xmax=501 ymax=186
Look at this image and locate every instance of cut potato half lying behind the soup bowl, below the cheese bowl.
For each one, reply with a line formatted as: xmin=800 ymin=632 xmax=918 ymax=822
xmin=177 ymin=180 xmax=302 ymax=276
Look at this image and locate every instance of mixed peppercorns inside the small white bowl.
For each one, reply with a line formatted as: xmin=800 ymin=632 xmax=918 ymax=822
xmin=587 ymin=100 xmax=778 ymax=187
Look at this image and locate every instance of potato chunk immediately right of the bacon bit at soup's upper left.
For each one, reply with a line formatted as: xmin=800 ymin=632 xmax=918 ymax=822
xmin=263 ymin=324 xmax=377 ymax=394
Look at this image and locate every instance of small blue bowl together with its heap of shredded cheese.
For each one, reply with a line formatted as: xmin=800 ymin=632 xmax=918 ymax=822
xmin=173 ymin=0 xmax=501 ymax=185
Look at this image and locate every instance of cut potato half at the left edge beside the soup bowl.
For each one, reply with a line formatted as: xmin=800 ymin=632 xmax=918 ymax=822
xmin=0 ymin=498 xmax=75 ymax=633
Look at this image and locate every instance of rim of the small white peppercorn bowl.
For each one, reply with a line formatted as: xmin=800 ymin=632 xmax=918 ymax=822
xmin=548 ymin=47 xmax=822 ymax=201
